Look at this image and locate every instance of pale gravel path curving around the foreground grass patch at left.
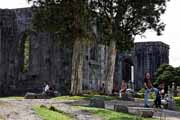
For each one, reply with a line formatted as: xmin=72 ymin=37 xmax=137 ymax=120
xmin=0 ymin=99 xmax=101 ymax=120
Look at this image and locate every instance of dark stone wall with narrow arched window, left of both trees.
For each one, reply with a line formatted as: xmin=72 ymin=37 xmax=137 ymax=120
xmin=0 ymin=8 xmax=72 ymax=95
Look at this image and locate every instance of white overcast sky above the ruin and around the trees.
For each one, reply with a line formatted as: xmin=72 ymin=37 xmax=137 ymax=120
xmin=0 ymin=0 xmax=180 ymax=67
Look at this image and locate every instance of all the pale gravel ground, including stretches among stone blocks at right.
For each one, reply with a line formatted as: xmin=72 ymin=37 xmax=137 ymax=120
xmin=0 ymin=99 xmax=180 ymax=120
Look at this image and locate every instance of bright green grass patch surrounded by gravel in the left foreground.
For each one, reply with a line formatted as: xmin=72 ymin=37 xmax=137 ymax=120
xmin=33 ymin=106 xmax=73 ymax=120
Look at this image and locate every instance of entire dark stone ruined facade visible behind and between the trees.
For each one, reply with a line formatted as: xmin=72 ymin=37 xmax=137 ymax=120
xmin=0 ymin=8 xmax=169 ymax=95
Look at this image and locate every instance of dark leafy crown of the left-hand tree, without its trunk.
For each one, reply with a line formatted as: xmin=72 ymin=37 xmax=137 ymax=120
xmin=28 ymin=0 xmax=91 ymax=46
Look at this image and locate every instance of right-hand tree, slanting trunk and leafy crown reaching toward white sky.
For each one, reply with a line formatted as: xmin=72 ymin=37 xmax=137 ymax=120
xmin=89 ymin=0 xmax=167 ymax=94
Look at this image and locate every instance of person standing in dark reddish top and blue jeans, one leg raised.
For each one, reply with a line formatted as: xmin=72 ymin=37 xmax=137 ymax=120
xmin=144 ymin=72 xmax=158 ymax=107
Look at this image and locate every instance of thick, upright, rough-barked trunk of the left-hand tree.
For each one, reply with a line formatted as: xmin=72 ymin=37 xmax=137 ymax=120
xmin=70 ymin=38 xmax=83 ymax=95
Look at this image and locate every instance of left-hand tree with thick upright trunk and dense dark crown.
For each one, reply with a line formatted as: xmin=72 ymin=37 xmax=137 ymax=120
xmin=29 ymin=0 xmax=89 ymax=95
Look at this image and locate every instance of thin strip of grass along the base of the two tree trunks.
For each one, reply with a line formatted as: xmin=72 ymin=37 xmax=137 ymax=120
xmin=53 ymin=95 xmax=117 ymax=101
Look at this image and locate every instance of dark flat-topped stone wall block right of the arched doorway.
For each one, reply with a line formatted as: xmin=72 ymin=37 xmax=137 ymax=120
xmin=134 ymin=42 xmax=169 ymax=89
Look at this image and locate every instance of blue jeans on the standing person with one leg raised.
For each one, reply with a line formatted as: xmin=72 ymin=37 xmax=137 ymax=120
xmin=144 ymin=87 xmax=159 ymax=106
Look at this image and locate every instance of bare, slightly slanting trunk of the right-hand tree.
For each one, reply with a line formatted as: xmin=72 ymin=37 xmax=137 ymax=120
xmin=105 ymin=40 xmax=116 ymax=95
